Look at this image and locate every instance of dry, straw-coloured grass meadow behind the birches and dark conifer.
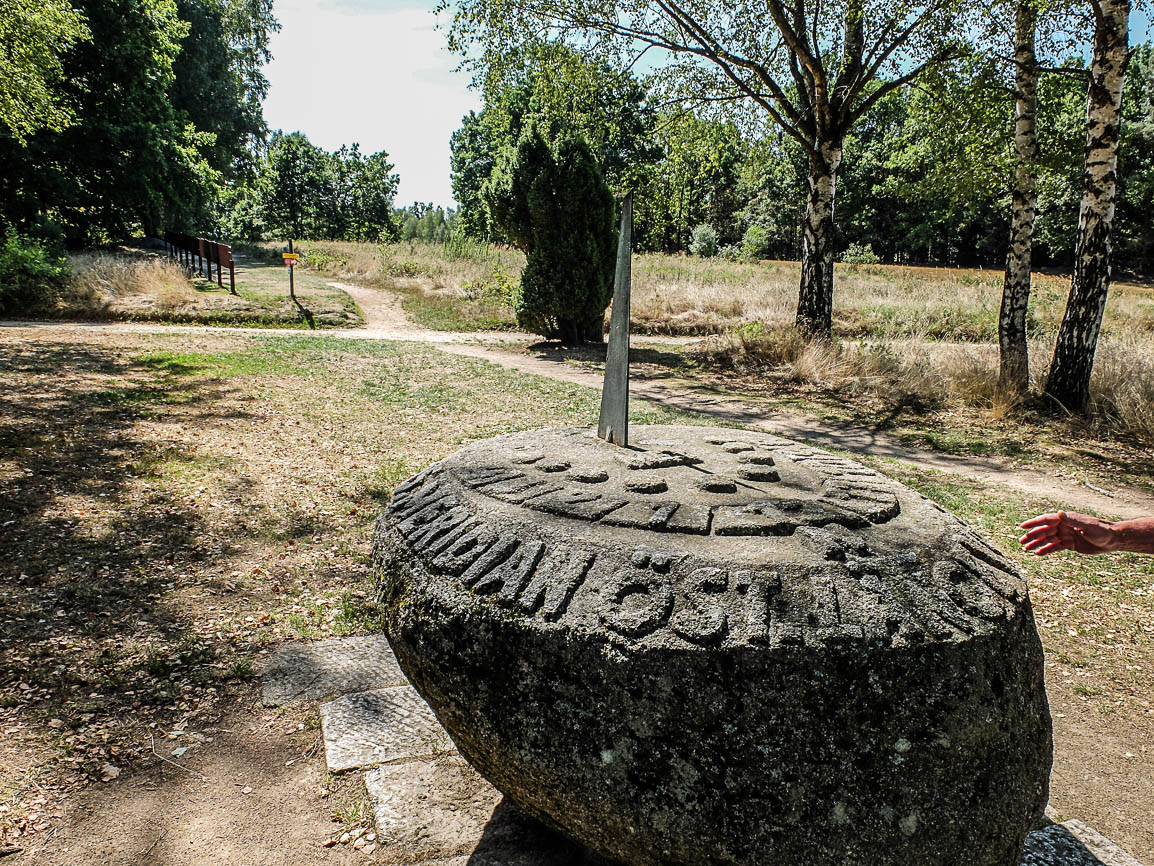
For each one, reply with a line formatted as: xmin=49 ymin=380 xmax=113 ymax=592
xmin=293 ymin=239 xmax=1154 ymax=446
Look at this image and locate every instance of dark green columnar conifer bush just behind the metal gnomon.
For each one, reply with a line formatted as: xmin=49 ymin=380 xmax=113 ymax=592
xmin=482 ymin=121 xmax=616 ymax=344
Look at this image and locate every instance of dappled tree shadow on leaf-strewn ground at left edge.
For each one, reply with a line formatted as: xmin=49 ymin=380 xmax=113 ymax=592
xmin=0 ymin=342 xmax=255 ymax=775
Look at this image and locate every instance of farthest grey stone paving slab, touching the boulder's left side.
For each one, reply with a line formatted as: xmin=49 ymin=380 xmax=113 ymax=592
xmin=263 ymin=635 xmax=407 ymax=707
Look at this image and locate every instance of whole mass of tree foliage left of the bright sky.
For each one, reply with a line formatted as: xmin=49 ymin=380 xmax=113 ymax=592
xmin=0 ymin=0 xmax=277 ymax=245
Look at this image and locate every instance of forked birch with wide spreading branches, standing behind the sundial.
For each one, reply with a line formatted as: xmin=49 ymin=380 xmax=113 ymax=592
xmin=450 ymin=0 xmax=962 ymax=335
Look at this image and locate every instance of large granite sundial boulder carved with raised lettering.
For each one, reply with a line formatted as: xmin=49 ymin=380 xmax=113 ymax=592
xmin=376 ymin=427 xmax=1051 ymax=866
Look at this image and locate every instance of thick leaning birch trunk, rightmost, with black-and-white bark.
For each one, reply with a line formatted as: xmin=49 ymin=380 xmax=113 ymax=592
xmin=1046 ymin=0 xmax=1130 ymax=412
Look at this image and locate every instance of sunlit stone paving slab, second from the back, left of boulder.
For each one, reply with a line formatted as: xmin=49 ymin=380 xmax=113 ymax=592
xmin=321 ymin=686 xmax=452 ymax=772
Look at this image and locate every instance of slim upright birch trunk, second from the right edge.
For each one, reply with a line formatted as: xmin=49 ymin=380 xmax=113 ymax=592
xmin=998 ymin=0 xmax=1037 ymax=394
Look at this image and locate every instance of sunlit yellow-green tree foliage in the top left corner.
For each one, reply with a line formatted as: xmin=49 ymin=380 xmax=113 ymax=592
xmin=0 ymin=0 xmax=91 ymax=144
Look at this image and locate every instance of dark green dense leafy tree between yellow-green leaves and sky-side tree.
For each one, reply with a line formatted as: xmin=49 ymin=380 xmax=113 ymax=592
xmin=0 ymin=0 xmax=218 ymax=244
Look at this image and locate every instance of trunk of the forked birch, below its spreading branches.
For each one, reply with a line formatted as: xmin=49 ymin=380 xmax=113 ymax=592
xmin=796 ymin=141 xmax=841 ymax=338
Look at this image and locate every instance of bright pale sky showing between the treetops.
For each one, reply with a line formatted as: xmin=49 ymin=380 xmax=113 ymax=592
xmin=264 ymin=0 xmax=1151 ymax=207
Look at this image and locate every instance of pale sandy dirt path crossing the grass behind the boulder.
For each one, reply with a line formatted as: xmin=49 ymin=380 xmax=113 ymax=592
xmin=9 ymin=282 xmax=1154 ymax=518
